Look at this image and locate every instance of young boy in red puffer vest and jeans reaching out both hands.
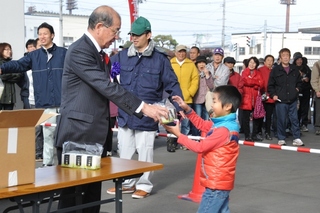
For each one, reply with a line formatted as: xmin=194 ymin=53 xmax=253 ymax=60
xmin=163 ymin=85 xmax=241 ymax=213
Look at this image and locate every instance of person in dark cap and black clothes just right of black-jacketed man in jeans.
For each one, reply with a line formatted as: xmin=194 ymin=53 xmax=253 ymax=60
xmin=293 ymin=52 xmax=312 ymax=132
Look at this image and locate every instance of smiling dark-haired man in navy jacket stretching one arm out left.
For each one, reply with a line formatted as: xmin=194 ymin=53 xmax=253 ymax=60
xmin=0 ymin=22 xmax=67 ymax=166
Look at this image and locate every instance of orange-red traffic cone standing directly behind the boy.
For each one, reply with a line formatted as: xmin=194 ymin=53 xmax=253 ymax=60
xmin=178 ymin=131 xmax=205 ymax=203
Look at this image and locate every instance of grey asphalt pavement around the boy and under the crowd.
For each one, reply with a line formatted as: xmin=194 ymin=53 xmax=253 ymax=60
xmin=0 ymin=124 xmax=320 ymax=213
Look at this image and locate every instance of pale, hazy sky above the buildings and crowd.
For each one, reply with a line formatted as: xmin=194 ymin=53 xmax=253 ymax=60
xmin=25 ymin=0 xmax=320 ymax=45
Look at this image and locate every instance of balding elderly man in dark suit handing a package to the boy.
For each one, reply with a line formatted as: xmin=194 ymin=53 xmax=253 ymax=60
xmin=56 ymin=6 xmax=168 ymax=213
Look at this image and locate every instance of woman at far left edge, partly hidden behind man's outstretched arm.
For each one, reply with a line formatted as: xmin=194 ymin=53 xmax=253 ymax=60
xmin=0 ymin=43 xmax=23 ymax=110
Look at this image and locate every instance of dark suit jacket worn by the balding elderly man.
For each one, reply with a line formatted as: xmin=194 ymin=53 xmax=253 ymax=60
xmin=55 ymin=35 xmax=143 ymax=147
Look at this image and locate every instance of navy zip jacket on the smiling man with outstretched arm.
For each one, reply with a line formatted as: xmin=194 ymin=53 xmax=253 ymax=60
xmin=1 ymin=44 xmax=67 ymax=108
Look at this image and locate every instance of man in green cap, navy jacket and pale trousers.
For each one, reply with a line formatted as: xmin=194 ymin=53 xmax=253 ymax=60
xmin=107 ymin=16 xmax=182 ymax=199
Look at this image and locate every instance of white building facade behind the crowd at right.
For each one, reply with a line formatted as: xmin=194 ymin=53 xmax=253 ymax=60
xmin=228 ymin=29 xmax=320 ymax=71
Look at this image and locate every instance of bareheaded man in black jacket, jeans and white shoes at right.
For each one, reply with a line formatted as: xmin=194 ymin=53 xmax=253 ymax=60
xmin=267 ymin=48 xmax=304 ymax=146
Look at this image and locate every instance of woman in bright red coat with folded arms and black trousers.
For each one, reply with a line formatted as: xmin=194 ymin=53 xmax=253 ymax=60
xmin=240 ymin=57 xmax=264 ymax=141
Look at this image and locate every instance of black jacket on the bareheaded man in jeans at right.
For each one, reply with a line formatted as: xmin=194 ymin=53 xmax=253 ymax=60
xmin=268 ymin=64 xmax=302 ymax=103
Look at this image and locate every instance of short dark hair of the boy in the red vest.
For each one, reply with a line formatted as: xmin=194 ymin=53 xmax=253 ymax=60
xmin=213 ymin=85 xmax=242 ymax=113
